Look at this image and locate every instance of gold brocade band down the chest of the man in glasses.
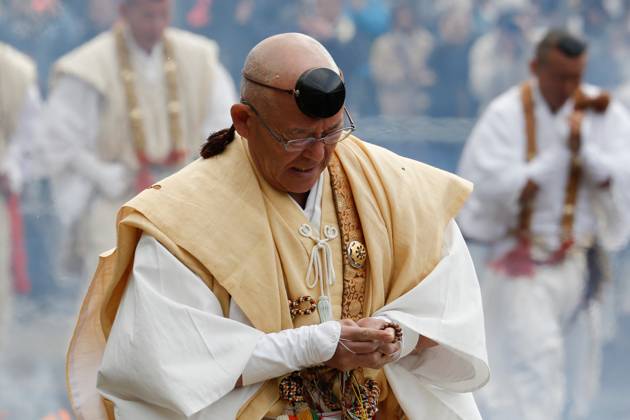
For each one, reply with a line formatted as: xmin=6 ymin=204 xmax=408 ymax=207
xmin=328 ymin=154 xmax=369 ymax=321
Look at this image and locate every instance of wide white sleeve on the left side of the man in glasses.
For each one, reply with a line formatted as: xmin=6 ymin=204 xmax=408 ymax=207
xmin=97 ymin=235 xmax=263 ymax=419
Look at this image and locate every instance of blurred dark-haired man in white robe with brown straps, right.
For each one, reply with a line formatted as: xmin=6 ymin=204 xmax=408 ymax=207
xmin=459 ymin=30 xmax=630 ymax=420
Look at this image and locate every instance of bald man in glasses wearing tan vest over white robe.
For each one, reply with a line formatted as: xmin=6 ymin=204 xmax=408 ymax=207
xmin=68 ymin=33 xmax=489 ymax=420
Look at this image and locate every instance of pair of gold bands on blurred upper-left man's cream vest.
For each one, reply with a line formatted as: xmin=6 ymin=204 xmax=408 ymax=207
xmin=114 ymin=24 xmax=186 ymax=165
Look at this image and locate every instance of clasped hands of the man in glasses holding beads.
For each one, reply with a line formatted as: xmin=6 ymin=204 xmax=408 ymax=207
xmin=326 ymin=318 xmax=401 ymax=371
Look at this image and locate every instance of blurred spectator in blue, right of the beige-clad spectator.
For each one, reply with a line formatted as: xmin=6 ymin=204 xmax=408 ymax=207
xmin=428 ymin=8 xmax=477 ymax=117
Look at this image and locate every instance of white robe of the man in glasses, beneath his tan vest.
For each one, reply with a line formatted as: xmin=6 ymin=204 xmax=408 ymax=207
xmin=98 ymin=178 xmax=489 ymax=420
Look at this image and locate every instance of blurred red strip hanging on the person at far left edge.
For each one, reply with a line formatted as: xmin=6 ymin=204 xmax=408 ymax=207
xmin=7 ymin=194 xmax=31 ymax=294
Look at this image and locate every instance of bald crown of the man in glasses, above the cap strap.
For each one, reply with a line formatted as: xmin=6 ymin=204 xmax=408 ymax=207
xmin=241 ymin=33 xmax=340 ymax=100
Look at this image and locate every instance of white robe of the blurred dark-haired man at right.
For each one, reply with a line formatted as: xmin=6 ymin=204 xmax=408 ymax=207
xmin=459 ymin=80 xmax=630 ymax=420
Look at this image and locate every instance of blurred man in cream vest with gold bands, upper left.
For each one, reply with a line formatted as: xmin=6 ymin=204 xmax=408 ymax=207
xmin=45 ymin=0 xmax=236 ymax=282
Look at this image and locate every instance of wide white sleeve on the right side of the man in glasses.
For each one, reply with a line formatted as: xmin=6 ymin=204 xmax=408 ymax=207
xmin=375 ymin=221 xmax=490 ymax=419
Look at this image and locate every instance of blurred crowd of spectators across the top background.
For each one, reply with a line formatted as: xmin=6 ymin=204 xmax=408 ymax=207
xmin=0 ymin=0 xmax=630 ymax=117
